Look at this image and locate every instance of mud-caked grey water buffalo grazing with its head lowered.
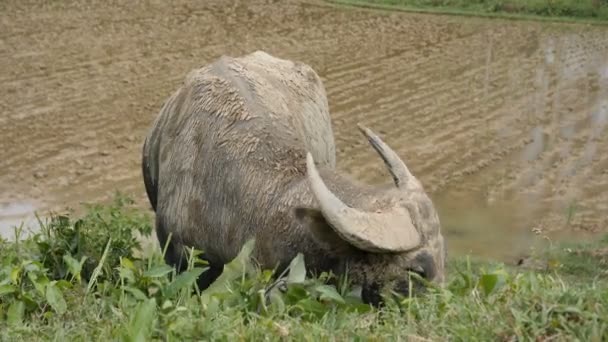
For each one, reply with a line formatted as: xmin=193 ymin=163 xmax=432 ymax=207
xmin=142 ymin=51 xmax=446 ymax=305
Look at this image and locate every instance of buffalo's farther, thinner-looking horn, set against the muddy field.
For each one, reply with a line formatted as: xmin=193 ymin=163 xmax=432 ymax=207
xmin=357 ymin=124 xmax=420 ymax=189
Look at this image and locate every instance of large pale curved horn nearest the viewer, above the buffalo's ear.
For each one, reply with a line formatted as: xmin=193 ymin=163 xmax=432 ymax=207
xmin=306 ymin=153 xmax=421 ymax=252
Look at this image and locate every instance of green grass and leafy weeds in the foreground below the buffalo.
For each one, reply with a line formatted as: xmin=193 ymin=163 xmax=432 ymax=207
xmin=0 ymin=197 xmax=608 ymax=341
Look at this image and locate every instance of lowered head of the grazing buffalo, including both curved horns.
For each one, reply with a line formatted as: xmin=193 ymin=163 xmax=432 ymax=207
xmin=296 ymin=125 xmax=446 ymax=305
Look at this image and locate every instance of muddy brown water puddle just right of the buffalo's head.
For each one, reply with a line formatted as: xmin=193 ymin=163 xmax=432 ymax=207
xmin=433 ymin=192 xmax=591 ymax=264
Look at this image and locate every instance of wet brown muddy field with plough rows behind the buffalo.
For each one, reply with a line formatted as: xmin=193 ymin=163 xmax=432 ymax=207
xmin=0 ymin=0 xmax=608 ymax=258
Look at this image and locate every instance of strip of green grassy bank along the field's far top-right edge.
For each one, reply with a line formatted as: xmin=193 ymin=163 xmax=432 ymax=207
xmin=328 ymin=0 xmax=608 ymax=23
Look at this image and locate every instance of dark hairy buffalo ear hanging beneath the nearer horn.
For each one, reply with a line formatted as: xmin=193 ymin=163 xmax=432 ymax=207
xmin=294 ymin=207 xmax=356 ymax=255
